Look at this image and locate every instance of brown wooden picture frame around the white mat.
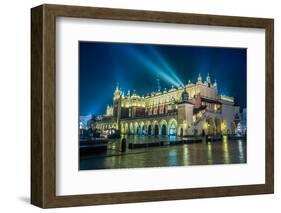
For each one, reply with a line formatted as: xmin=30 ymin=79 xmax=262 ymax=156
xmin=31 ymin=4 xmax=274 ymax=208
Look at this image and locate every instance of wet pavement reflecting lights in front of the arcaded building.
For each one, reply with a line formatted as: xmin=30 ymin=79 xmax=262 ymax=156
xmin=79 ymin=136 xmax=247 ymax=170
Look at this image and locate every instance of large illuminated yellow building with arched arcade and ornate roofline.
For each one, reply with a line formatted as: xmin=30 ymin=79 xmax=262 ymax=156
xmin=91 ymin=74 xmax=240 ymax=136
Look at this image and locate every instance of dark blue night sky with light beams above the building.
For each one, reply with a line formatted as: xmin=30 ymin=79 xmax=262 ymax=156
xmin=79 ymin=41 xmax=247 ymax=115
